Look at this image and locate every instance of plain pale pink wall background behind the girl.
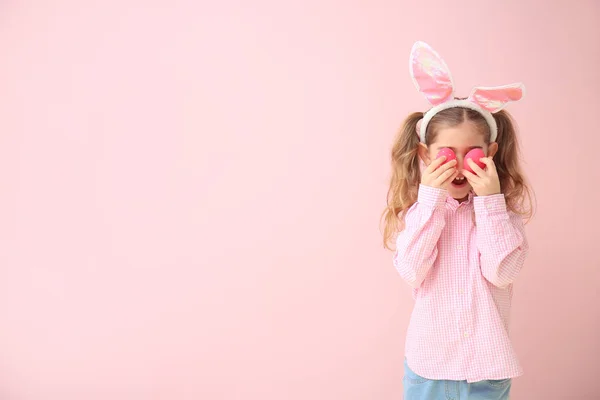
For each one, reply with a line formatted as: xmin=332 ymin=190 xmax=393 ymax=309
xmin=0 ymin=0 xmax=600 ymax=400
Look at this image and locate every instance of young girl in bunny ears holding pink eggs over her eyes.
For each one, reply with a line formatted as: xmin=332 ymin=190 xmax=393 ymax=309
xmin=384 ymin=42 xmax=531 ymax=400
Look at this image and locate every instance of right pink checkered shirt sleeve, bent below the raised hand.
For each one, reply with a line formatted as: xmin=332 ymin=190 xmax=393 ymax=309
xmin=474 ymin=194 xmax=529 ymax=288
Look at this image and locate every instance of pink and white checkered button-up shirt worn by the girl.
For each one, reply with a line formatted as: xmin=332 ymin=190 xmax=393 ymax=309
xmin=394 ymin=185 xmax=528 ymax=382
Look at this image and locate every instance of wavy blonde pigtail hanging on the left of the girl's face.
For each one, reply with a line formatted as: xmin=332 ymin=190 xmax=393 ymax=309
xmin=382 ymin=112 xmax=423 ymax=249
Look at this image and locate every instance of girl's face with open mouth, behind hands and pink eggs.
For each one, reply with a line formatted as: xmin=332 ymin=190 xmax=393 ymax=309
xmin=419 ymin=121 xmax=498 ymax=201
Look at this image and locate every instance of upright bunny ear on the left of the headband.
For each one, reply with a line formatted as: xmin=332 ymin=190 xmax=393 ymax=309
xmin=409 ymin=42 xmax=454 ymax=106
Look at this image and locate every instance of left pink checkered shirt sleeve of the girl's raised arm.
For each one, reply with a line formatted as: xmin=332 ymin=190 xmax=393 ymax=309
xmin=394 ymin=185 xmax=448 ymax=288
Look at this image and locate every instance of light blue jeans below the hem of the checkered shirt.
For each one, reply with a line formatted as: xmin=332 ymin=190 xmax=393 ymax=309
xmin=403 ymin=360 xmax=511 ymax=400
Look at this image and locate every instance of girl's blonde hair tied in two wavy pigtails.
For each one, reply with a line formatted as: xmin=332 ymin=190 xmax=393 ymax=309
xmin=382 ymin=107 xmax=533 ymax=250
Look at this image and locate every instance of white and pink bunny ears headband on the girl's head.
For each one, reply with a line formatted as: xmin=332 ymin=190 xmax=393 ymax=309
xmin=410 ymin=42 xmax=525 ymax=143
